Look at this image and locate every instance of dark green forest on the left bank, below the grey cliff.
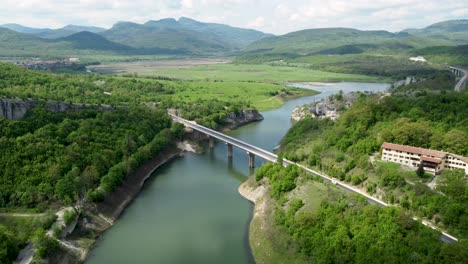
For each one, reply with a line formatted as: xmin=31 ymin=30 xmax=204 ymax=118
xmin=0 ymin=107 xmax=171 ymax=208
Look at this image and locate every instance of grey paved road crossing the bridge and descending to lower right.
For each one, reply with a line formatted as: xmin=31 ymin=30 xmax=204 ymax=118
xmin=169 ymin=114 xmax=458 ymax=242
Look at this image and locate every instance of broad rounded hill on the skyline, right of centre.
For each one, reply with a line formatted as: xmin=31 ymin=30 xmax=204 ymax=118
xmin=244 ymin=28 xmax=452 ymax=55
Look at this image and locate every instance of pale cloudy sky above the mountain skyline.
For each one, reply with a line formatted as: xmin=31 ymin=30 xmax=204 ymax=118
xmin=0 ymin=0 xmax=468 ymax=34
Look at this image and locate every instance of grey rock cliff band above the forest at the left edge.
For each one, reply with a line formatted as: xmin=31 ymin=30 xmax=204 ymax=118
xmin=0 ymin=99 xmax=113 ymax=120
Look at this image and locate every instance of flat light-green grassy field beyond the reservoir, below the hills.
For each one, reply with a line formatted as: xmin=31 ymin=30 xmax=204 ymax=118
xmin=91 ymin=61 xmax=380 ymax=83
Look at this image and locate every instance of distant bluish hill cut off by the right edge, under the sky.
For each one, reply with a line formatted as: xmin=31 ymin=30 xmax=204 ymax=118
xmin=403 ymin=19 xmax=468 ymax=44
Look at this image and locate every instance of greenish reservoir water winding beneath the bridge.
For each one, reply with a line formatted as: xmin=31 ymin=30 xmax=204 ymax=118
xmin=86 ymin=82 xmax=389 ymax=264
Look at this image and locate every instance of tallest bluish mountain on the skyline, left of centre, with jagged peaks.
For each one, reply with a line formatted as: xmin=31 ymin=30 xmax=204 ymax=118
xmin=100 ymin=17 xmax=269 ymax=53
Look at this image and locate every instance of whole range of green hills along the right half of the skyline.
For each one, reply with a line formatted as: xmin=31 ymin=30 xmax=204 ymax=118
xmin=245 ymin=20 xmax=468 ymax=55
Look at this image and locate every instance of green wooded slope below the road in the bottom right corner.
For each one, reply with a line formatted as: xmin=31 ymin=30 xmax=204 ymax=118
xmin=256 ymin=164 xmax=468 ymax=263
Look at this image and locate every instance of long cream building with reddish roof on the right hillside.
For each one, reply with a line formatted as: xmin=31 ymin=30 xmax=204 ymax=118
xmin=382 ymin=142 xmax=468 ymax=174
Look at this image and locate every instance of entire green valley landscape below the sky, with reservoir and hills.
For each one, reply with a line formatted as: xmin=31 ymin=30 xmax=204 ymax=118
xmin=0 ymin=11 xmax=468 ymax=263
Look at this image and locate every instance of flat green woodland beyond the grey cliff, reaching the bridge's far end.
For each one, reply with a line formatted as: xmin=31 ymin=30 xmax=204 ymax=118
xmin=0 ymin=63 xmax=252 ymax=128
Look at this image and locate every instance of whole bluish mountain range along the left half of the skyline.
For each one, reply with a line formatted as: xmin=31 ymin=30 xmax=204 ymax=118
xmin=0 ymin=17 xmax=272 ymax=54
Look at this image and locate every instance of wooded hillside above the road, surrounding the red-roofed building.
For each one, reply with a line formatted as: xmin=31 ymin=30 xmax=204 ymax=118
xmin=282 ymin=75 xmax=468 ymax=243
